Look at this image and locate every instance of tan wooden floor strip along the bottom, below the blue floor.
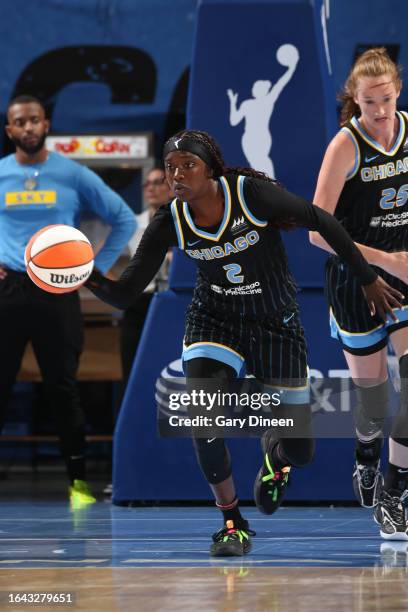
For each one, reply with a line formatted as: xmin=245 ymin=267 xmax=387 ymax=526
xmin=0 ymin=565 xmax=408 ymax=612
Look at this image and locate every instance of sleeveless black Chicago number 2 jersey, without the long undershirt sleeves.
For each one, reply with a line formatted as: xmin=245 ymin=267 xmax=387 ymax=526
xmin=171 ymin=175 xmax=296 ymax=314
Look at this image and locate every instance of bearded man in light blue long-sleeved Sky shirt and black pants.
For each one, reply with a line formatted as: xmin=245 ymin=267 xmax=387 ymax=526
xmin=0 ymin=96 xmax=136 ymax=505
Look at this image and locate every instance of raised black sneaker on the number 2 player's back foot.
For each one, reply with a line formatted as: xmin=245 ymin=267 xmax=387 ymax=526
xmin=254 ymin=431 xmax=290 ymax=514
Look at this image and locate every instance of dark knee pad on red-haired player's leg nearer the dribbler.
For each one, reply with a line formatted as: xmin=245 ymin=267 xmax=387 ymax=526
xmin=354 ymin=380 xmax=389 ymax=442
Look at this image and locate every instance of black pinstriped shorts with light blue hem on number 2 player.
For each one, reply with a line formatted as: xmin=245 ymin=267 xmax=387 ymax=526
xmin=183 ymin=303 xmax=309 ymax=404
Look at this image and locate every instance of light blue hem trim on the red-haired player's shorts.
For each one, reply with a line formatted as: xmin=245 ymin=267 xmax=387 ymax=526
xmin=330 ymin=306 xmax=408 ymax=349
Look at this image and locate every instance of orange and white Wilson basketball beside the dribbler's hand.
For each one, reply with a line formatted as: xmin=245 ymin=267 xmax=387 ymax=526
xmin=24 ymin=225 xmax=94 ymax=293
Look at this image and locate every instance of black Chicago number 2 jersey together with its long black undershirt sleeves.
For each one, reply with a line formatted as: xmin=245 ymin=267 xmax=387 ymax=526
xmin=89 ymin=174 xmax=376 ymax=315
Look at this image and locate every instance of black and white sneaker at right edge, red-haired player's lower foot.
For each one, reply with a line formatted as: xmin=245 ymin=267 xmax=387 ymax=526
xmin=374 ymin=489 xmax=408 ymax=540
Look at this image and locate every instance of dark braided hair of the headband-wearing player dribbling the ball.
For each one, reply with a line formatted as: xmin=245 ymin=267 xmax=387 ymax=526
xmin=164 ymin=130 xmax=296 ymax=230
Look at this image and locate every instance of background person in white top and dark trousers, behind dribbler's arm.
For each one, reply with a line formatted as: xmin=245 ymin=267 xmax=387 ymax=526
xmin=120 ymin=166 xmax=173 ymax=392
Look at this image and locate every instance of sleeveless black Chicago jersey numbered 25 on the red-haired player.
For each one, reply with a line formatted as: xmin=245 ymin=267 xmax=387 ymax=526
xmin=335 ymin=112 xmax=408 ymax=252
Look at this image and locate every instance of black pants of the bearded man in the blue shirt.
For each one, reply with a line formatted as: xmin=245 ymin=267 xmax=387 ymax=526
xmin=0 ymin=271 xmax=85 ymax=480
